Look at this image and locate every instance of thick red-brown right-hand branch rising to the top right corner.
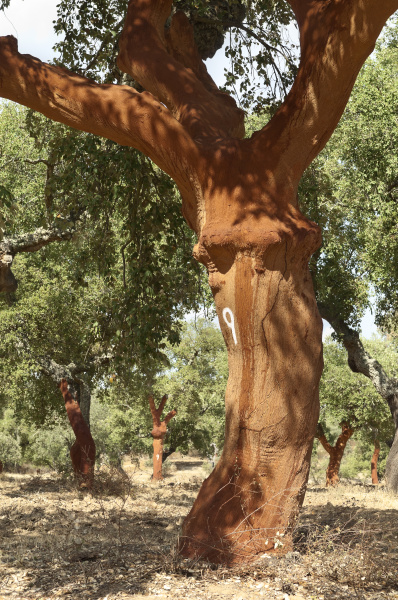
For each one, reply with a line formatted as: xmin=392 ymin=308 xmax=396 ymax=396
xmin=252 ymin=0 xmax=398 ymax=187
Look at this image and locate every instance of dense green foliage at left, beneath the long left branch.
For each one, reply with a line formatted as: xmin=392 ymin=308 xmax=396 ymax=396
xmin=0 ymin=105 xmax=207 ymax=478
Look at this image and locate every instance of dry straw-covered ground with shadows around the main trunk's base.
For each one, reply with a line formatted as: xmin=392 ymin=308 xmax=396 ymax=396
xmin=0 ymin=459 xmax=398 ymax=600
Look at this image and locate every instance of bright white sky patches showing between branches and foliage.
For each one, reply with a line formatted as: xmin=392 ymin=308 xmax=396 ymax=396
xmin=0 ymin=0 xmax=377 ymax=339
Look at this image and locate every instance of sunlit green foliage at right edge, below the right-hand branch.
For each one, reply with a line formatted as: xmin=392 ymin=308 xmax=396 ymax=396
xmin=300 ymin=21 xmax=398 ymax=330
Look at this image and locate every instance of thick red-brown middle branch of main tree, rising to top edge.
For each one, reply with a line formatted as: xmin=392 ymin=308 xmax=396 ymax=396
xmin=117 ymin=0 xmax=244 ymax=139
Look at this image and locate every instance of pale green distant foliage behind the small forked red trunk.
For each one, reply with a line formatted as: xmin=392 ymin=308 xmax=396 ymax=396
xmin=94 ymin=319 xmax=228 ymax=461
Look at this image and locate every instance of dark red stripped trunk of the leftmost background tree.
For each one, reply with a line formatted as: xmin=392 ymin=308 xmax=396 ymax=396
xmin=59 ymin=379 xmax=95 ymax=487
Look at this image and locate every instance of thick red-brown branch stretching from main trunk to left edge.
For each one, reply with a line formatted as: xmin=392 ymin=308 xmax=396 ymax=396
xmin=0 ymin=36 xmax=198 ymax=196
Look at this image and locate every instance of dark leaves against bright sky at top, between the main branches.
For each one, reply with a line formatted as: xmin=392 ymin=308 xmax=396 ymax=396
xmin=54 ymin=0 xmax=297 ymax=112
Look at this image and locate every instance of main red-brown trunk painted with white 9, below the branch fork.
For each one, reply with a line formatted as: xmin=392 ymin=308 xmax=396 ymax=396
xmin=181 ymin=211 xmax=322 ymax=563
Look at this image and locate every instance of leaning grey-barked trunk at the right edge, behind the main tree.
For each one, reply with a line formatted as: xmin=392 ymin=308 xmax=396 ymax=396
xmin=318 ymin=304 xmax=398 ymax=494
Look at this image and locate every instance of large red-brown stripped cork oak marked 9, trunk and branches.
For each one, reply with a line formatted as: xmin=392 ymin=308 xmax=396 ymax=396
xmin=0 ymin=0 xmax=398 ymax=563
